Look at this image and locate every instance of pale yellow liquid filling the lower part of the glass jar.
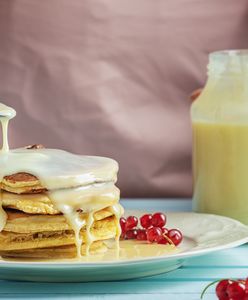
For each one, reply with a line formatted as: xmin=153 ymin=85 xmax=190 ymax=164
xmin=193 ymin=122 xmax=248 ymax=224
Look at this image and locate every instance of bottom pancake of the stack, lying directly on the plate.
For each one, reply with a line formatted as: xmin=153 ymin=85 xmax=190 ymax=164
xmin=0 ymin=241 xmax=108 ymax=259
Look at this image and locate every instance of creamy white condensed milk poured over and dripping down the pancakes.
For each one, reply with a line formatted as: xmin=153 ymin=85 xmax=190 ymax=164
xmin=0 ymin=104 xmax=123 ymax=257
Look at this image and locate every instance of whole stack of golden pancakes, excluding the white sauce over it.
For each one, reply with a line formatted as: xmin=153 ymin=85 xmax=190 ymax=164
xmin=0 ymin=172 xmax=121 ymax=258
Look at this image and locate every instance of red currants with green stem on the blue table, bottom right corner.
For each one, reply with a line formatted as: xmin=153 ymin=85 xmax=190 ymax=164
xmin=201 ymin=278 xmax=248 ymax=300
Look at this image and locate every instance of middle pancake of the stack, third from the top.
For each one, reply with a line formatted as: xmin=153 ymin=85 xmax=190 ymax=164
xmin=3 ymin=208 xmax=116 ymax=234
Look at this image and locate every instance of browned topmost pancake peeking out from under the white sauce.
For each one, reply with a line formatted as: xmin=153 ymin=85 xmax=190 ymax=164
xmin=1 ymin=172 xmax=46 ymax=194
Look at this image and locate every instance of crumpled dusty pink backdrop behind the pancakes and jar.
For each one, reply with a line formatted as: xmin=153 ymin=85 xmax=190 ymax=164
xmin=0 ymin=0 xmax=248 ymax=197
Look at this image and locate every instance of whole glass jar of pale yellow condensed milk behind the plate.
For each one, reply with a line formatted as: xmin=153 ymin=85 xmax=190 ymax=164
xmin=191 ymin=50 xmax=248 ymax=224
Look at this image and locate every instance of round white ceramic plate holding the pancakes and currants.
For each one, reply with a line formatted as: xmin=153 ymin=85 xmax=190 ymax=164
xmin=0 ymin=211 xmax=248 ymax=282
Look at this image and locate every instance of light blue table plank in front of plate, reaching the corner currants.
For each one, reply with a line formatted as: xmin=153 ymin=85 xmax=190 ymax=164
xmin=0 ymin=281 xmax=217 ymax=299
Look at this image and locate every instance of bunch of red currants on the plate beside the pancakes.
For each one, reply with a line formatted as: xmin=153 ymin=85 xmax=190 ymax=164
xmin=120 ymin=212 xmax=183 ymax=246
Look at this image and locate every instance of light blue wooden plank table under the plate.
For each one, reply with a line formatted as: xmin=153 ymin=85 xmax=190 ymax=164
xmin=0 ymin=199 xmax=248 ymax=300
